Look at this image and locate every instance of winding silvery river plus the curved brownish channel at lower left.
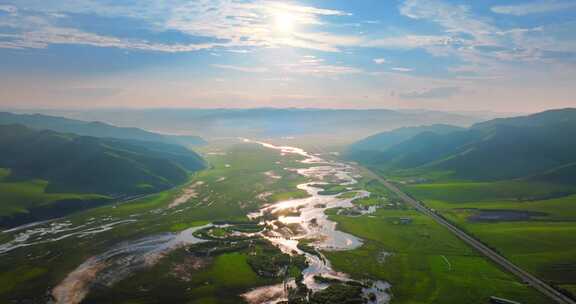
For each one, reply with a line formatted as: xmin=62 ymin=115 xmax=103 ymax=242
xmin=47 ymin=139 xmax=390 ymax=304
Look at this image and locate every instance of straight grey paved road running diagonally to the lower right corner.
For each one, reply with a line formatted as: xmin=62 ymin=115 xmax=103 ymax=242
xmin=364 ymin=168 xmax=576 ymax=304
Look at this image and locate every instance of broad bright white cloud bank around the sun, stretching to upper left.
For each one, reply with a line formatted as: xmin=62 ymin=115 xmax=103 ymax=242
xmin=0 ymin=0 xmax=358 ymax=52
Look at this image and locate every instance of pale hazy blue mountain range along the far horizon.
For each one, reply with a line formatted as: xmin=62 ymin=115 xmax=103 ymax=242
xmin=21 ymin=108 xmax=486 ymax=140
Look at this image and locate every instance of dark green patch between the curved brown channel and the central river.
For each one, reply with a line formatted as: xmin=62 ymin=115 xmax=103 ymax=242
xmin=85 ymin=240 xmax=306 ymax=303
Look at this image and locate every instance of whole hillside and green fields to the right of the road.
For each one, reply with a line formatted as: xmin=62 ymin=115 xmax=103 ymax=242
xmin=346 ymin=109 xmax=576 ymax=302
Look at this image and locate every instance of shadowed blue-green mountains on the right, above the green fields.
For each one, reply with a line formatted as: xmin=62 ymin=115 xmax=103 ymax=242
xmin=348 ymin=109 xmax=576 ymax=183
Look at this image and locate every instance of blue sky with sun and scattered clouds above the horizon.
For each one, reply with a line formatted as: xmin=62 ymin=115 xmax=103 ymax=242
xmin=0 ymin=0 xmax=576 ymax=112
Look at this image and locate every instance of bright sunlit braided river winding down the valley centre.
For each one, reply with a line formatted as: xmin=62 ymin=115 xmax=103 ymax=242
xmin=243 ymin=139 xmax=390 ymax=304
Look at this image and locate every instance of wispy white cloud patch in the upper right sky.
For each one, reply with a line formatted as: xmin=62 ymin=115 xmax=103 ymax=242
xmin=390 ymin=0 xmax=575 ymax=73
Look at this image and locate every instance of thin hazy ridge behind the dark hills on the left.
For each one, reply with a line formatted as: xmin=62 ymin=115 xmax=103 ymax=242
xmin=0 ymin=112 xmax=206 ymax=145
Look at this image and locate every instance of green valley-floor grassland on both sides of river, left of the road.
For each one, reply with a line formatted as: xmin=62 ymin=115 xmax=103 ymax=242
xmin=0 ymin=144 xmax=563 ymax=304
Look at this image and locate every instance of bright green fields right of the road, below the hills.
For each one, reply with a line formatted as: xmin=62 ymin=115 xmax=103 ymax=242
xmin=404 ymin=182 xmax=576 ymax=293
